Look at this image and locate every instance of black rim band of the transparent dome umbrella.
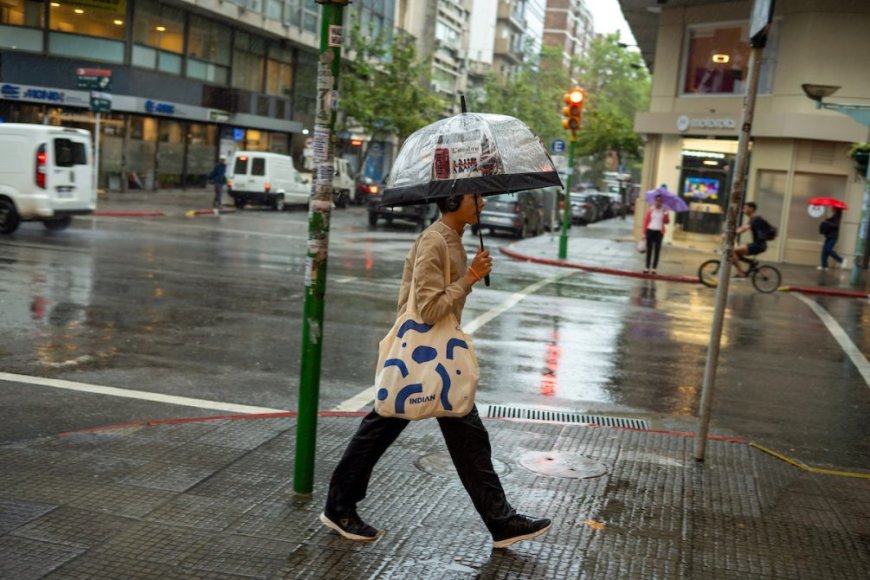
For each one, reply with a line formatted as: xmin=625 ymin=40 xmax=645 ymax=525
xmin=381 ymin=171 xmax=562 ymax=206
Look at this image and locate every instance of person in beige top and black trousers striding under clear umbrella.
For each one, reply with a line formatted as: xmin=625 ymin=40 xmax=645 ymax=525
xmin=320 ymin=193 xmax=551 ymax=548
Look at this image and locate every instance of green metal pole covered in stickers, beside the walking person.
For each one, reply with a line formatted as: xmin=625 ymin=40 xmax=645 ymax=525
xmin=293 ymin=2 xmax=346 ymax=494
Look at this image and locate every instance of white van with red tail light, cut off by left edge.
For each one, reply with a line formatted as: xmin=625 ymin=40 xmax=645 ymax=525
xmin=0 ymin=123 xmax=97 ymax=234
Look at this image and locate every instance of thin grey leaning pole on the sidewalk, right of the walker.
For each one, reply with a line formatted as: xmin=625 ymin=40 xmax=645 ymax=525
xmin=694 ymin=47 xmax=762 ymax=461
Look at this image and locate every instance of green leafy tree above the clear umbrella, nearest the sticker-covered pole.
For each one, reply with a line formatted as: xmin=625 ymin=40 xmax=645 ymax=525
xmin=340 ymin=19 xmax=444 ymax=177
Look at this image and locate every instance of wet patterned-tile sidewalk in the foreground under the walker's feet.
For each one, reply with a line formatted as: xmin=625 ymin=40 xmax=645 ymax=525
xmin=0 ymin=416 xmax=870 ymax=580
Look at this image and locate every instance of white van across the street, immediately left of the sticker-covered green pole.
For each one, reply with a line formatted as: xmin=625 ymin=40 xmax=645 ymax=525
xmin=227 ymin=151 xmax=311 ymax=211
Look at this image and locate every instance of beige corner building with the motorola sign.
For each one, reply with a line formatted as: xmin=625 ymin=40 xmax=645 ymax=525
xmin=620 ymin=0 xmax=870 ymax=265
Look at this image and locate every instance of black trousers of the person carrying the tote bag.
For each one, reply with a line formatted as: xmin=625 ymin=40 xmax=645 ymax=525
xmin=326 ymin=407 xmax=516 ymax=531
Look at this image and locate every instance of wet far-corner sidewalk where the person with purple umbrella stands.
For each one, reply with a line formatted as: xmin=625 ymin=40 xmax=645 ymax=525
xmin=501 ymin=218 xmax=870 ymax=298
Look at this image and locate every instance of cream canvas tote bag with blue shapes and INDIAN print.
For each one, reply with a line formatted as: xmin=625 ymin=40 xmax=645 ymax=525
xmin=375 ymin=236 xmax=480 ymax=421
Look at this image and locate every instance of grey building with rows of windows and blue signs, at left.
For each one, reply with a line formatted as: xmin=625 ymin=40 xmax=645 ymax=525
xmin=0 ymin=0 xmax=330 ymax=190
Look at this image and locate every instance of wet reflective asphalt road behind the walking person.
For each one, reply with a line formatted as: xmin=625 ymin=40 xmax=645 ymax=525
xmin=0 ymin=208 xmax=870 ymax=468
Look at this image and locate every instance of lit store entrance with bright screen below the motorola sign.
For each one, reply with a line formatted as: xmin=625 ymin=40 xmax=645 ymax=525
xmin=677 ymin=139 xmax=737 ymax=235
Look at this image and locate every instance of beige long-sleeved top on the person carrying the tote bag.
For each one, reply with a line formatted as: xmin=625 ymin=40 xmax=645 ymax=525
xmin=399 ymin=220 xmax=471 ymax=324
